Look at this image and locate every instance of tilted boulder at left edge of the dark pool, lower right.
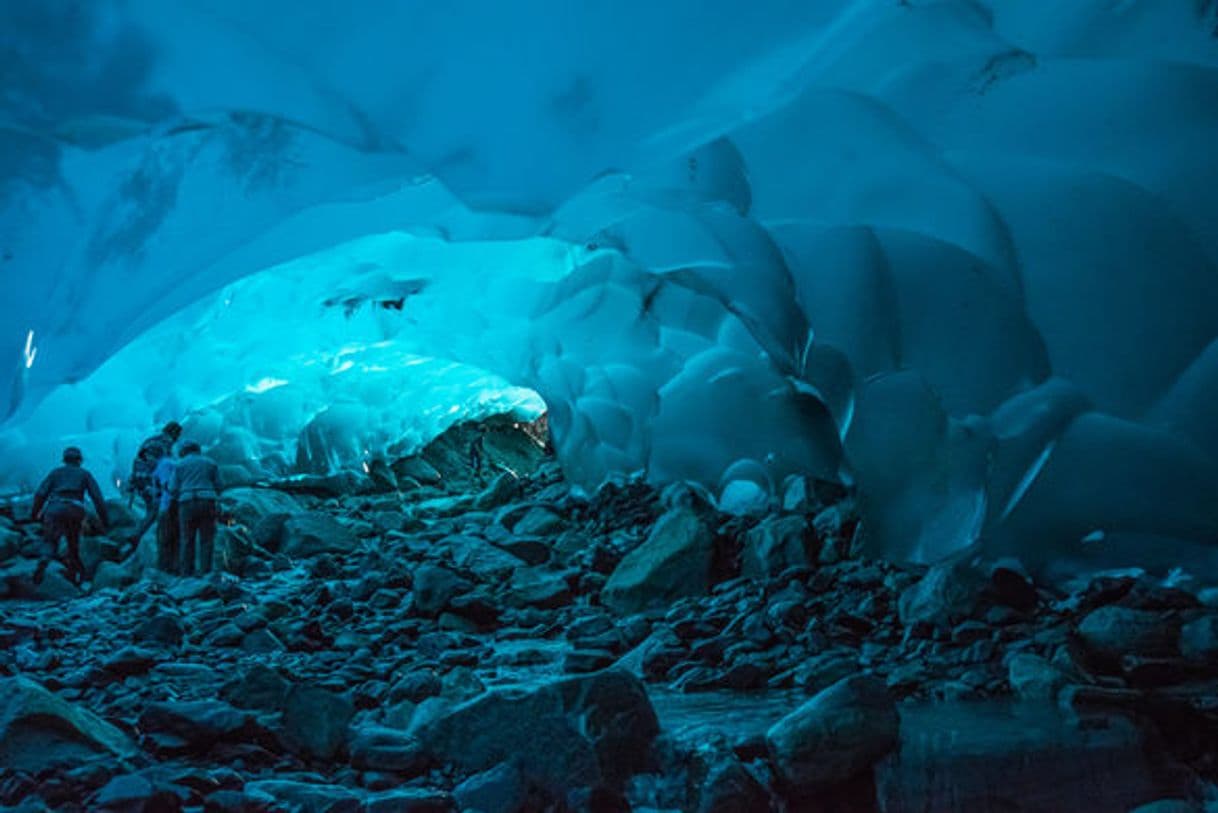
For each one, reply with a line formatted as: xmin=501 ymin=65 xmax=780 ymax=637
xmin=766 ymin=675 xmax=900 ymax=797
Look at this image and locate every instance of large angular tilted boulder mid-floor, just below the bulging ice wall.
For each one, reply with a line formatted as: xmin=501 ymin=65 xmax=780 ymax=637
xmin=600 ymin=507 xmax=715 ymax=614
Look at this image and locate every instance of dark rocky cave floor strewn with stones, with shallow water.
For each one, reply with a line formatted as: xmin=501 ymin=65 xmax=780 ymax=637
xmin=0 ymin=428 xmax=1218 ymax=813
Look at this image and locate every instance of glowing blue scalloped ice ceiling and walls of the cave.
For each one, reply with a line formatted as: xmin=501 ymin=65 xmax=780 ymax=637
xmin=0 ymin=0 xmax=1218 ymax=569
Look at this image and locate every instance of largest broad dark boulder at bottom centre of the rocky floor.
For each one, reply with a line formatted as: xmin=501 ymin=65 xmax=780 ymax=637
xmin=418 ymin=670 xmax=659 ymax=797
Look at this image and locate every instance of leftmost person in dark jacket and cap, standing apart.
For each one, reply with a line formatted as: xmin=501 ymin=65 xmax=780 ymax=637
xmin=30 ymin=446 xmax=110 ymax=584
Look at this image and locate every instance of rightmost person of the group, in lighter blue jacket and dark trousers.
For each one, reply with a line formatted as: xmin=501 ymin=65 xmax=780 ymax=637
xmin=169 ymin=442 xmax=220 ymax=575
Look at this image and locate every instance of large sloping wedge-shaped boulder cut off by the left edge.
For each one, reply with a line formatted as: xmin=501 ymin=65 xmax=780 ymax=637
xmin=0 ymin=676 xmax=136 ymax=773
